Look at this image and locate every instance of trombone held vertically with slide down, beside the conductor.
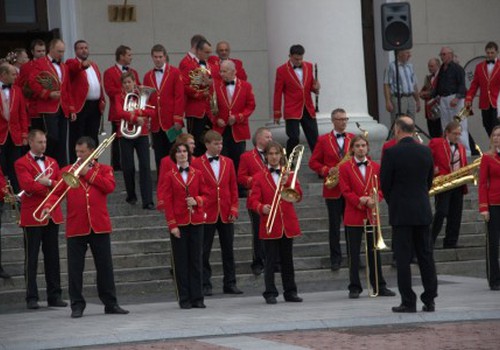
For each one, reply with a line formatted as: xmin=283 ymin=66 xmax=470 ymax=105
xmin=363 ymin=175 xmax=387 ymax=298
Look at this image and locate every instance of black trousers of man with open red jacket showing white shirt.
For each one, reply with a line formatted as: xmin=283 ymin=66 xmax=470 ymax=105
xmin=69 ymin=100 xmax=101 ymax=163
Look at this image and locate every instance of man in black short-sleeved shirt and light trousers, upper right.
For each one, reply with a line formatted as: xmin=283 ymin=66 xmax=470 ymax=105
xmin=433 ymin=46 xmax=470 ymax=154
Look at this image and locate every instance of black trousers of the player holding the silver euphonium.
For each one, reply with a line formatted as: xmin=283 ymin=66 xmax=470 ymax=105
xmin=120 ymin=136 xmax=153 ymax=206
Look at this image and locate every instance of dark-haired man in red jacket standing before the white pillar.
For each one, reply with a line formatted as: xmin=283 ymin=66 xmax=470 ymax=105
xmin=273 ymin=45 xmax=320 ymax=154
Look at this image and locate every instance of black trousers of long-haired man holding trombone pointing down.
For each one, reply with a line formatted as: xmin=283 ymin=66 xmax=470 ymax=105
xmin=345 ymin=226 xmax=386 ymax=293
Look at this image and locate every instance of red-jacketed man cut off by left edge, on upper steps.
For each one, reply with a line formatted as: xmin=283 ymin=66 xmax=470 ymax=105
xmin=0 ymin=63 xmax=28 ymax=193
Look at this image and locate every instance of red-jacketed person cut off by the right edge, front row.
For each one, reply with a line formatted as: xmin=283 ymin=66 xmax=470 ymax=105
xmin=479 ymin=125 xmax=500 ymax=290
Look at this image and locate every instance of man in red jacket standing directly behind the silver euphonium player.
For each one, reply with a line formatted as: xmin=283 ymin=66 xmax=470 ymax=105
xmin=103 ymin=45 xmax=141 ymax=170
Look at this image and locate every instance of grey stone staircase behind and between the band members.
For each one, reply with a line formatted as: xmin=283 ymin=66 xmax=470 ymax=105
xmin=0 ymin=157 xmax=486 ymax=305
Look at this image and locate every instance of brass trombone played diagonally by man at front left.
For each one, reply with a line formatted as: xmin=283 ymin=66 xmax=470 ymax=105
xmin=33 ymin=132 xmax=116 ymax=222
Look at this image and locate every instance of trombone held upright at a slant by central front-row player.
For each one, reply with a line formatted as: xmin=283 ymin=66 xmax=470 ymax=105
xmin=266 ymin=145 xmax=304 ymax=235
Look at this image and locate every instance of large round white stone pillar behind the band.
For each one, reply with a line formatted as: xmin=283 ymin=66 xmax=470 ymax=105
xmin=266 ymin=0 xmax=387 ymax=158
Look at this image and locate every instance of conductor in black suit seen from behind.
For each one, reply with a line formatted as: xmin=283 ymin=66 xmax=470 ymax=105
xmin=380 ymin=116 xmax=437 ymax=312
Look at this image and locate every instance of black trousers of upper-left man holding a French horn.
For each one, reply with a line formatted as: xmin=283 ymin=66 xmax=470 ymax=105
xmin=42 ymin=108 xmax=69 ymax=168
